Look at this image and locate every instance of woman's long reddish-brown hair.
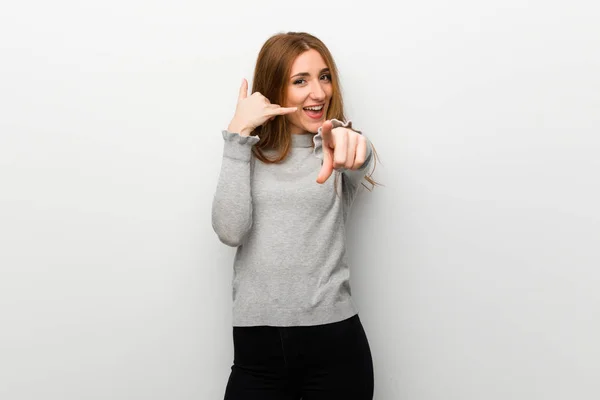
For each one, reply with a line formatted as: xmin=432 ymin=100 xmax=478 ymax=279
xmin=251 ymin=32 xmax=377 ymax=187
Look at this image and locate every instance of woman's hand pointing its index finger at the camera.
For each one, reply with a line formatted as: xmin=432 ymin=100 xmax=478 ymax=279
xmin=317 ymin=121 xmax=367 ymax=183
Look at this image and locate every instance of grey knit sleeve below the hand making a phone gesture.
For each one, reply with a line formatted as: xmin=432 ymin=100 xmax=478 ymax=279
xmin=212 ymin=130 xmax=259 ymax=247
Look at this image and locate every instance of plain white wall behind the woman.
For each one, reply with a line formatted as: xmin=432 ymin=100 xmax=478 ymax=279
xmin=0 ymin=0 xmax=600 ymax=400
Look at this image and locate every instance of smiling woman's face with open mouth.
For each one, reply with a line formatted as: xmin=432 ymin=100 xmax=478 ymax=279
xmin=283 ymin=49 xmax=333 ymax=134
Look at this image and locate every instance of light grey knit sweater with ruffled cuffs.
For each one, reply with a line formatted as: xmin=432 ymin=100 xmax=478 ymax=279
xmin=212 ymin=120 xmax=373 ymax=326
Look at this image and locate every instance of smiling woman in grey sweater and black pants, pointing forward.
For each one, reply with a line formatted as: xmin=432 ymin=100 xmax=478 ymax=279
xmin=212 ymin=32 xmax=376 ymax=400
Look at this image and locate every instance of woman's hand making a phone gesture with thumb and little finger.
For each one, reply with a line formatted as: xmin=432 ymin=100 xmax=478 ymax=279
xmin=227 ymin=79 xmax=298 ymax=136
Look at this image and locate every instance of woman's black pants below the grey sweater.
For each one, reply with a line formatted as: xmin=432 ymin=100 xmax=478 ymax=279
xmin=225 ymin=315 xmax=373 ymax=400
